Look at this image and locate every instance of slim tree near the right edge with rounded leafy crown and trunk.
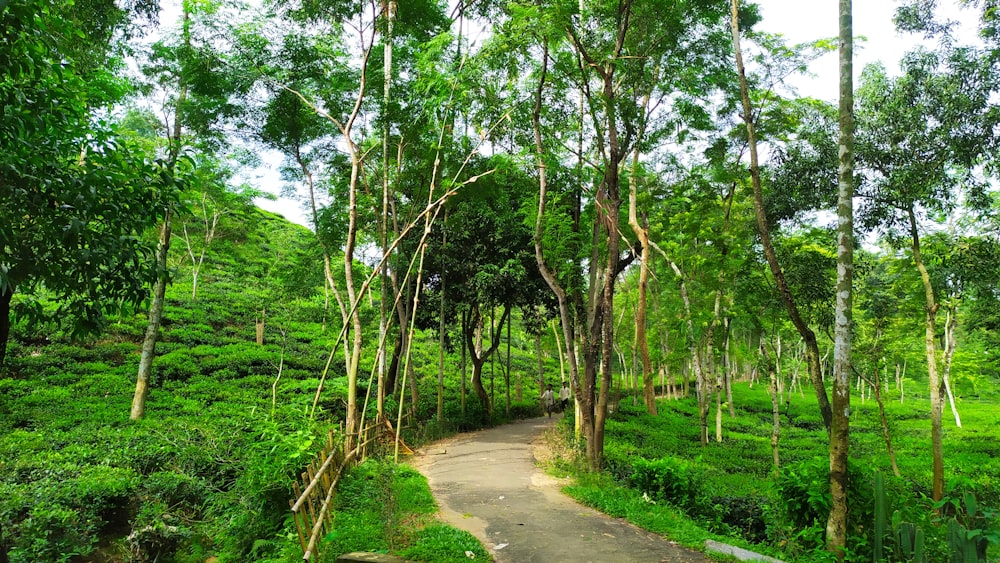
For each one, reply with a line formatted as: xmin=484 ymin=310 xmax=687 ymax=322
xmin=858 ymin=47 xmax=997 ymax=500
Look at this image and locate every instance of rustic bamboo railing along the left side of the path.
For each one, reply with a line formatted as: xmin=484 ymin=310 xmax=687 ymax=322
xmin=289 ymin=418 xmax=413 ymax=561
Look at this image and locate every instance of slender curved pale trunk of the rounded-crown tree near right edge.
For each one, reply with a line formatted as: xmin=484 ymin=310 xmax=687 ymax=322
xmin=907 ymin=206 xmax=944 ymax=502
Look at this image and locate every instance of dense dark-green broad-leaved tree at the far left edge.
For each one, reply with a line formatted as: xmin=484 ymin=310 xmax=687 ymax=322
xmin=0 ymin=2 xmax=169 ymax=366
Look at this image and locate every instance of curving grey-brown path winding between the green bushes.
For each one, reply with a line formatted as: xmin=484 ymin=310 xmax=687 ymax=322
xmin=413 ymin=418 xmax=709 ymax=563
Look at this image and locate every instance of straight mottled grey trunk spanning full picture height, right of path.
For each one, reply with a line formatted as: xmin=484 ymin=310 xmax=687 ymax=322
xmin=826 ymin=0 xmax=856 ymax=561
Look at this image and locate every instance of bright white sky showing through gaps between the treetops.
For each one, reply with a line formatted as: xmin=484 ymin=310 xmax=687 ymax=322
xmin=257 ymin=0 xmax=976 ymax=225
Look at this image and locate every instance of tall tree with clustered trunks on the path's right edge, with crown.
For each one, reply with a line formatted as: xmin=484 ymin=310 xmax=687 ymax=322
xmin=502 ymin=1 xmax=736 ymax=469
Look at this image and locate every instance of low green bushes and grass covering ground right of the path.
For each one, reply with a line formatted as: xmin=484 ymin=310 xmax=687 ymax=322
xmin=562 ymin=383 xmax=1000 ymax=561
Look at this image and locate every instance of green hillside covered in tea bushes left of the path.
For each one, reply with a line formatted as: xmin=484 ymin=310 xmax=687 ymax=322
xmin=0 ymin=209 xmax=364 ymax=562
